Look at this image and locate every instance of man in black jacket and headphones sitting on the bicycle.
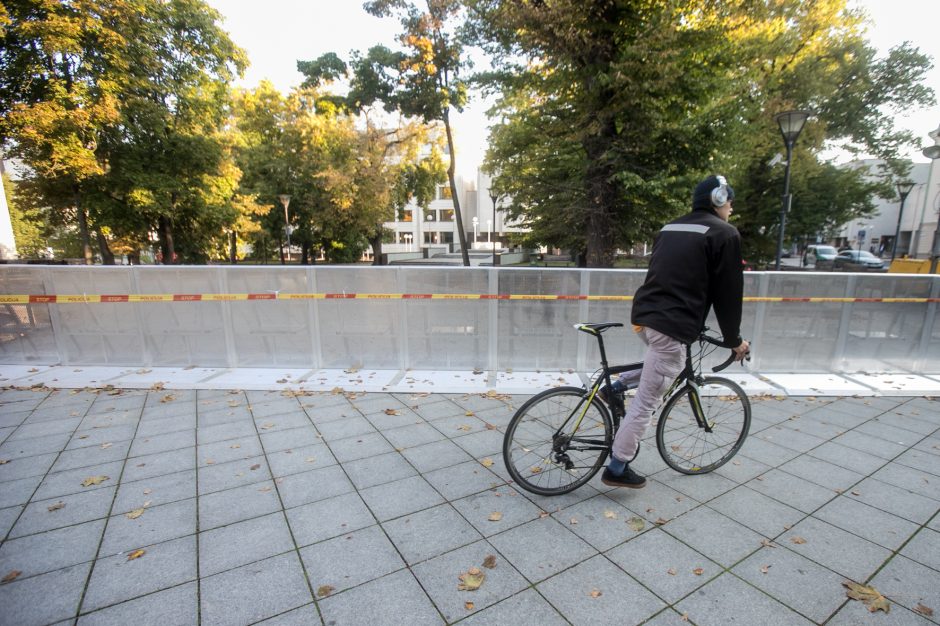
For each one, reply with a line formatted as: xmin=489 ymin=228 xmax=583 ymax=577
xmin=601 ymin=176 xmax=749 ymax=489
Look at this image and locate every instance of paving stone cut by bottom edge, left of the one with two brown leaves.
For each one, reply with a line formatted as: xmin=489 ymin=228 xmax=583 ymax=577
xmin=319 ymin=570 xmax=445 ymax=626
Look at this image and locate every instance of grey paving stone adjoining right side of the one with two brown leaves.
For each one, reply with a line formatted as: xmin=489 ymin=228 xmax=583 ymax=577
xmin=490 ymin=517 xmax=597 ymax=582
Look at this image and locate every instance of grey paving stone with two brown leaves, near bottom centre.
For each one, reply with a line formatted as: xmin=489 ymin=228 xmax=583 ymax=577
xmin=412 ymin=541 xmax=529 ymax=622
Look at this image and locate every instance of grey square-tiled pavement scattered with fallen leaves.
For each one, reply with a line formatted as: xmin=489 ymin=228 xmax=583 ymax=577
xmin=0 ymin=388 xmax=940 ymax=626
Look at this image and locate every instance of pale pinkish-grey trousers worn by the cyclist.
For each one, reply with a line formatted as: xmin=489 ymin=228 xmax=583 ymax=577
xmin=613 ymin=328 xmax=685 ymax=461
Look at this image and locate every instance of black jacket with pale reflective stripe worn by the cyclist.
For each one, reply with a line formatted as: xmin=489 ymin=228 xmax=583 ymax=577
xmin=631 ymin=209 xmax=744 ymax=348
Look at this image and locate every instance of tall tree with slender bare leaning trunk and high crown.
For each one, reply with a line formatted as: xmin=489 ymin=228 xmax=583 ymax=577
xmin=348 ymin=0 xmax=470 ymax=266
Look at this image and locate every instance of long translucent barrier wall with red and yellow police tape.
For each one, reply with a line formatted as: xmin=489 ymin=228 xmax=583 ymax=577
xmin=0 ymin=265 xmax=940 ymax=373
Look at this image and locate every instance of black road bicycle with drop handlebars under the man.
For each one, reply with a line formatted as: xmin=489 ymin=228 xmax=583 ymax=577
xmin=503 ymin=322 xmax=751 ymax=496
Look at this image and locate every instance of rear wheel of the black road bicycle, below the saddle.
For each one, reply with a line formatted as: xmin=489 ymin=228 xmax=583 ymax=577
xmin=503 ymin=387 xmax=613 ymax=496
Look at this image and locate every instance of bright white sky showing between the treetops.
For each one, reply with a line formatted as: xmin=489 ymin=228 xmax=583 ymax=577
xmin=207 ymin=0 xmax=940 ymax=178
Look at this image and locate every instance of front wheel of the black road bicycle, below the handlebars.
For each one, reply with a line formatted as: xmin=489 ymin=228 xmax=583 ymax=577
xmin=656 ymin=377 xmax=751 ymax=474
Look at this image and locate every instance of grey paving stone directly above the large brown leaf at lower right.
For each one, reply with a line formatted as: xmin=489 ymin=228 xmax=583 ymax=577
xmin=777 ymin=517 xmax=891 ymax=580
